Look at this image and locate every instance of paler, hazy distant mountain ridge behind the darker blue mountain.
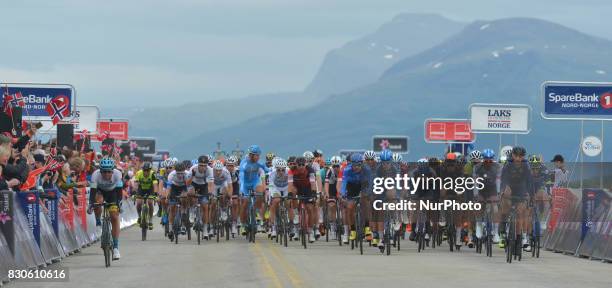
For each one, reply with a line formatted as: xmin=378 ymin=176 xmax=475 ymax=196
xmin=125 ymin=13 xmax=465 ymax=150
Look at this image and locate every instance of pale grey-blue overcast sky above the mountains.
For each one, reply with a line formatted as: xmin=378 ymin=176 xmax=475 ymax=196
xmin=0 ymin=0 xmax=612 ymax=107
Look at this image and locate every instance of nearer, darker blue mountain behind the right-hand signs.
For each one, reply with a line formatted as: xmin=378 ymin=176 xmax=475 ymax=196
xmin=171 ymin=18 xmax=612 ymax=158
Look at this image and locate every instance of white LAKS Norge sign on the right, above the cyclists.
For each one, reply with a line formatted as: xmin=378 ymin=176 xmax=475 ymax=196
xmin=470 ymin=103 xmax=531 ymax=134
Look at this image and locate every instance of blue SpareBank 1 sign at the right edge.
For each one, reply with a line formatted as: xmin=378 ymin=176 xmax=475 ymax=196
xmin=541 ymin=82 xmax=612 ymax=120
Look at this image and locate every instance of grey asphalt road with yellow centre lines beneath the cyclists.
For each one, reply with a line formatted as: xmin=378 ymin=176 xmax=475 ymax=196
xmin=8 ymin=218 xmax=612 ymax=288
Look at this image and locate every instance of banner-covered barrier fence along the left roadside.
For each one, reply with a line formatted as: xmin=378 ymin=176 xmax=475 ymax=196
xmin=0 ymin=188 xmax=138 ymax=285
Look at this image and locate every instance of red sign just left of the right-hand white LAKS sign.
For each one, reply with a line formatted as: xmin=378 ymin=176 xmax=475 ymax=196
xmin=425 ymin=119 xmax=474 ymax=142
